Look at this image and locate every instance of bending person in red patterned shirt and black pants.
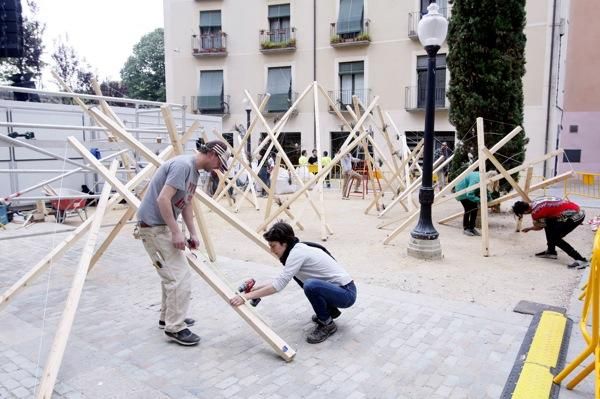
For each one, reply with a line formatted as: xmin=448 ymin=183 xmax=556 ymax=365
xmin=512 ymin=197 xmax=589 ymax=269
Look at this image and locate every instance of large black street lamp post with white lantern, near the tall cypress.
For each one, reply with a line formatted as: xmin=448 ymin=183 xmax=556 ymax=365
xmin=408 ymin=2 xmax=448 ymax=259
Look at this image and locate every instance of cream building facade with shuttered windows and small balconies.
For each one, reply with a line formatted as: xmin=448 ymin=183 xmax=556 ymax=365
xmin=164 ymin=0 xmax=560 ymax=174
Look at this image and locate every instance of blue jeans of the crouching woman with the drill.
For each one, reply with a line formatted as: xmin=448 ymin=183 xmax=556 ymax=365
xmin=304 ymin=278 xmax=356 ymax=322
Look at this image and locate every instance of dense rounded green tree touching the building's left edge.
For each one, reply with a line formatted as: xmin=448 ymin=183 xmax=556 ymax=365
xmin=121 ymin=28 xmax=166 ymax=101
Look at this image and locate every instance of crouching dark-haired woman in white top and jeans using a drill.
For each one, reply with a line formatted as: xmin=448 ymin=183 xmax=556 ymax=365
xmin=229 ymin=222 xmax=356 ymax=344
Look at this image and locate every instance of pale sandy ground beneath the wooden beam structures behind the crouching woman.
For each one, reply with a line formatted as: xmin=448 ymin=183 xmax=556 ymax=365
xmin=0 ymin=189 xmax=599 ymax=311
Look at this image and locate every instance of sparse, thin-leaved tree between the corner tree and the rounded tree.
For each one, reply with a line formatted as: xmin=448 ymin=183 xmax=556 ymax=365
xmin=51 ymin=37 xmax=94 ymax=94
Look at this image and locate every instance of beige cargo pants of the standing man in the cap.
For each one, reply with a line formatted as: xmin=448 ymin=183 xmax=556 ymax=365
xmin=139 ymin=226 xmax=191 ymax=333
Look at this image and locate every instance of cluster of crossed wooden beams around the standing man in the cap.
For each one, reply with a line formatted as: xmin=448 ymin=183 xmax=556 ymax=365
xmin=0 ymin=86 xmax=295 ymax=399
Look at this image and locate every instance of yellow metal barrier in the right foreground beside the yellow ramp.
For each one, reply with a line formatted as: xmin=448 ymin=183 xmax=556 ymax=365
xmin=554 ymin=230 xmax=600 ymax=399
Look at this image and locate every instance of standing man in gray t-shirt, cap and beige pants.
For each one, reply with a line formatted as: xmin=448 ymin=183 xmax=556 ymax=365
xmin=137 ymin=140 xmax=229 ymax=345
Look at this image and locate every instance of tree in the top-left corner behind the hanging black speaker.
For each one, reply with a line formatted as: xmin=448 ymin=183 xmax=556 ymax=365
xmin=0 ymin=0 xmax=46 ymax=82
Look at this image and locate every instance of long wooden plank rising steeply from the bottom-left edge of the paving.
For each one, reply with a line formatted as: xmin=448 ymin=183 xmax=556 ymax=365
xmin=36 ymin=161 xmax=118 ymax=399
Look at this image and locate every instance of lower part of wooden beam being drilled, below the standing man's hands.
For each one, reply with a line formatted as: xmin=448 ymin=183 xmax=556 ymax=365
xmin=186 ymin=250 xmax=296 ymax=362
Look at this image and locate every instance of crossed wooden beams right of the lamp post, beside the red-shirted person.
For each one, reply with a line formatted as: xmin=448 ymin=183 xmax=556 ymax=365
xmin=378 ymin=118 xmax=573 ymax=256
